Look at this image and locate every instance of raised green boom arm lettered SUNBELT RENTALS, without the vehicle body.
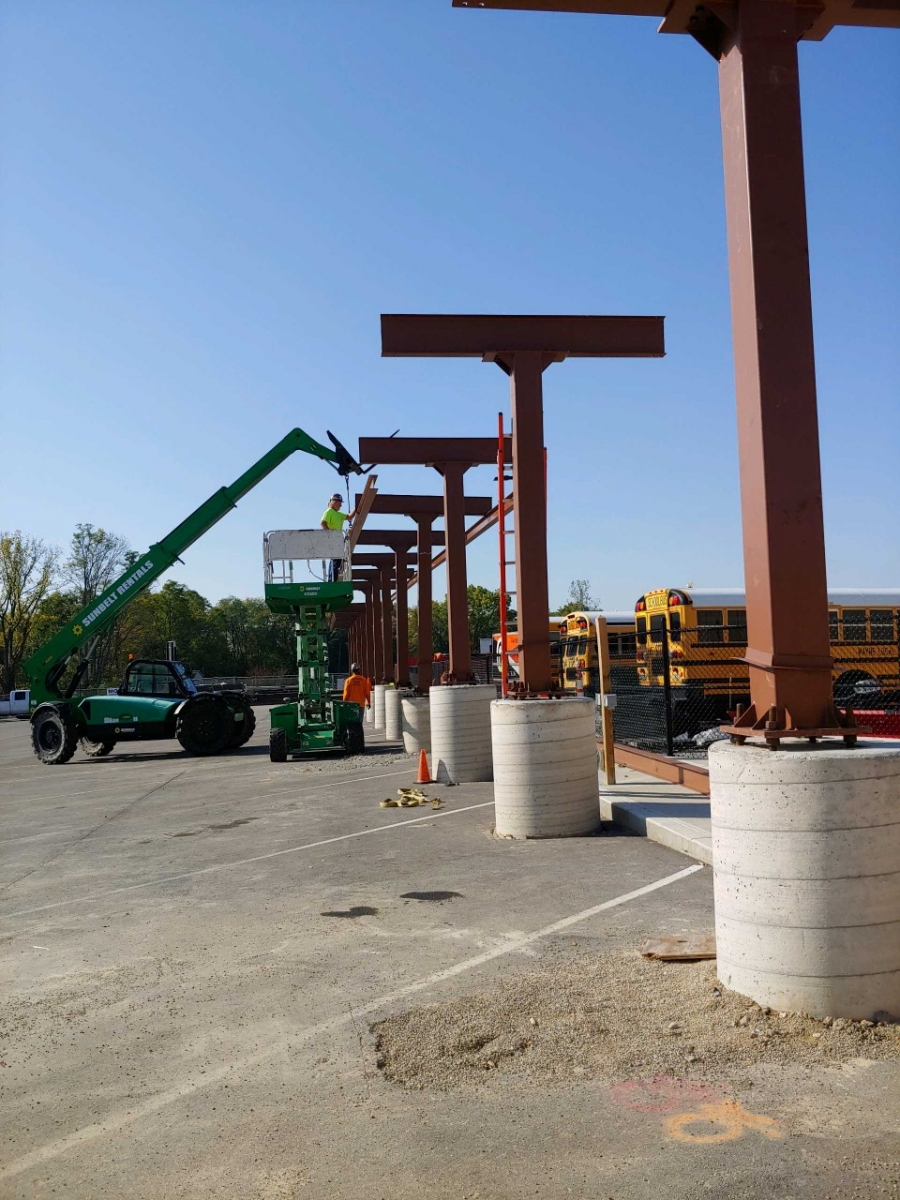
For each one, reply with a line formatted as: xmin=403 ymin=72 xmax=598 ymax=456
xmin=25 ymin=428 xmax=362 ymax=708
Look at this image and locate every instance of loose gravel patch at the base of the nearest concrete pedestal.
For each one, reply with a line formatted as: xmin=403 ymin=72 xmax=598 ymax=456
xmin=371 ymin=950 xmax=900 ymax=1091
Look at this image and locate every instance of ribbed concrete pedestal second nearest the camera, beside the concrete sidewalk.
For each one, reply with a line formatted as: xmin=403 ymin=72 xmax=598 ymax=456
xmin=491 ymin=697 xmax=600 ymax=838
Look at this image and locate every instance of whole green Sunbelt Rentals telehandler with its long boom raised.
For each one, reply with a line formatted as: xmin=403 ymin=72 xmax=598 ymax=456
xmin=25 ymin=430 xmax=362 ymax=764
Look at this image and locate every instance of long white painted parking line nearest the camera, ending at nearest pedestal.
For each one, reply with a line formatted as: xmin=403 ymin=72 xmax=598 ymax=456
xmin=0 ymin=864 xmax=703 ymax=1180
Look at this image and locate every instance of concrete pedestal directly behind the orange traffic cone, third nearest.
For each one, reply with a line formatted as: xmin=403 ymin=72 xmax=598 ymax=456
xmin=428 ymin=684 xmax=497 ymax=784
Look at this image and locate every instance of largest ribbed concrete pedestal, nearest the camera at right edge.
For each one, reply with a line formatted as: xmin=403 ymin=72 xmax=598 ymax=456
xmin=709 ymin=742 xmax=900 ymax=1020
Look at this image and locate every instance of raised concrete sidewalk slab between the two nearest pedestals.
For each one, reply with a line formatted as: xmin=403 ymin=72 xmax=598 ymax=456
xmin=600 ymin=767 xmax=713 ymax=865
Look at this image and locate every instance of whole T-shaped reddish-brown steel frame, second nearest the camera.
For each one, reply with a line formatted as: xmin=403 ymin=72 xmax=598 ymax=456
xmin=376 ymin=313 xmax=665 ymax=695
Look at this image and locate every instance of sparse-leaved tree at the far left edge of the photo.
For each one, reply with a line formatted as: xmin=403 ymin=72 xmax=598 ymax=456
xmin=0 ymin=529 xmax=59 ymax=691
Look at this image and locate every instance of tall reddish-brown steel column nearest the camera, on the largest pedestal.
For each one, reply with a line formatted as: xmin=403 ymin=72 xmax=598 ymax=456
xmin=719 ymin=0 xmax=839 ymax=731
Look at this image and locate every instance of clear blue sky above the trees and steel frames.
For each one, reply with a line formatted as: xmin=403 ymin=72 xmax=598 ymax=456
xmin=0 ymin=0 xmax=900 ymax=608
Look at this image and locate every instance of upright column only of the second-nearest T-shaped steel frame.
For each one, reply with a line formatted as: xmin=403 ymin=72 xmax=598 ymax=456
xmin=509 ymin=353 xmax=553 ymax=692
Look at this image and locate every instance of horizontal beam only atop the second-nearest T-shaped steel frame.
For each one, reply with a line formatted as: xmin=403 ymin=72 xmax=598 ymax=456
xmin=384 ymin=314 xmax=665 ymax=355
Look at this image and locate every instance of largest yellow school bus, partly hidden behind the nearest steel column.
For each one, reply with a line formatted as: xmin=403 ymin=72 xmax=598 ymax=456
xmin=635 ymin=588 xmax=900 ymax=715
